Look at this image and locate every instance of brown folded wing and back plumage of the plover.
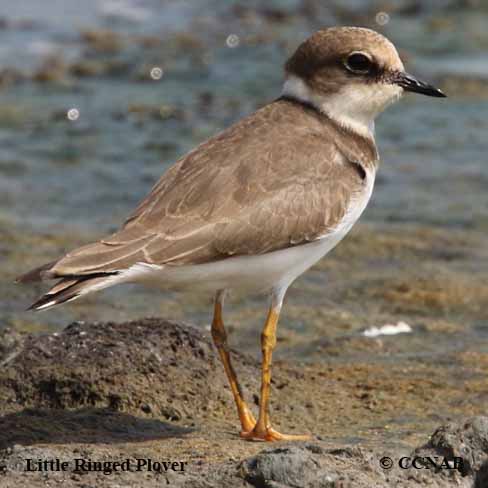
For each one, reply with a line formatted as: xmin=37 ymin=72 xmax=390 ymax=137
xmin=50 ymin=100 xmax=376 ymax=276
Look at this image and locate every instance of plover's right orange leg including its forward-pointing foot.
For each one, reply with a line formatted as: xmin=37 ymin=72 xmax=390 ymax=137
xmin=241 ymin=294 xmax=310 ymax=441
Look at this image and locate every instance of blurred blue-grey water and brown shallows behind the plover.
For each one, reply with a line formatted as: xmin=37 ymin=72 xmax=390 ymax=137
xmin=0 ymin=0 xmax=488 ymax=361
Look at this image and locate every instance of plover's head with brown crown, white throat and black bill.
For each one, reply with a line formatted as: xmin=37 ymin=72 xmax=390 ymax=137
xmin=283 ymin=27 xmax=445 ymax=136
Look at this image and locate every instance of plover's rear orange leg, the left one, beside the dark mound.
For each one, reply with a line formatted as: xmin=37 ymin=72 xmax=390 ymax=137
xmin=212 ymin=291 xmax=256 ymax=435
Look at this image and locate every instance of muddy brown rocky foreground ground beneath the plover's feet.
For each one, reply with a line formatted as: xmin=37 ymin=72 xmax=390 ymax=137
xmin=0 ymin=319 xmax=488 ymax=488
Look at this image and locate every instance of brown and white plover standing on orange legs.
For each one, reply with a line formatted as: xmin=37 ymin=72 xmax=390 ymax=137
xmin=18 ymin=27 xmax=446 ymax=441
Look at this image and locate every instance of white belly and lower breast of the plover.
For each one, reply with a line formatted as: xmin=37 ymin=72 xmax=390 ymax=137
xmin=121 ymin=172 xmax=375 ymax=292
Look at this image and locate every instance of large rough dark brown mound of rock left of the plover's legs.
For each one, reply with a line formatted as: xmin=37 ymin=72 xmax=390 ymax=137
xmin=0 ymin=319 xmax=259 ymax=420
